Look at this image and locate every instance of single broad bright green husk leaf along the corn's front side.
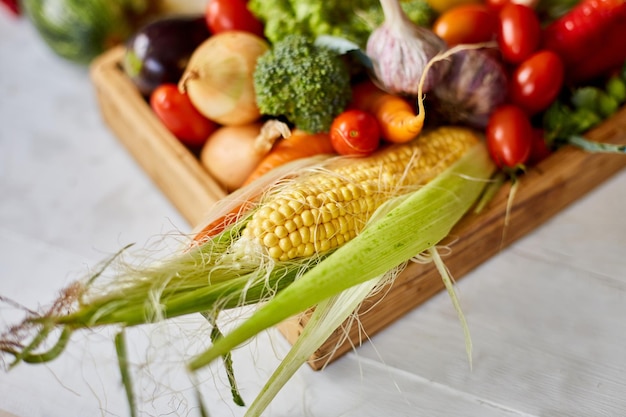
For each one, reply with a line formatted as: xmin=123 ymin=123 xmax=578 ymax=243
xmin=189 ymin=140 xmax=494 ymax=370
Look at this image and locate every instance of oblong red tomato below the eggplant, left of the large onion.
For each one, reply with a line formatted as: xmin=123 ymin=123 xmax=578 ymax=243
xmin=150 ymin=84 xmax=218 ymax=147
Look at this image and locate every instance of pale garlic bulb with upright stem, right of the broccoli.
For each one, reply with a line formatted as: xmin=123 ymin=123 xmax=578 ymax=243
xmin=366 ymin=0 xmax=450 ymax=96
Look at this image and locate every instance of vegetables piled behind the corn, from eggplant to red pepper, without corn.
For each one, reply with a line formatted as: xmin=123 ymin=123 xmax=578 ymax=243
xmin=114 ymin=0 xmax=626 ymax=192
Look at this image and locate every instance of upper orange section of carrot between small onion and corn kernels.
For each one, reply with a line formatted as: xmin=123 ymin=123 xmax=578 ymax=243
xmin=243 ymin=131 xmax=336 ymax=185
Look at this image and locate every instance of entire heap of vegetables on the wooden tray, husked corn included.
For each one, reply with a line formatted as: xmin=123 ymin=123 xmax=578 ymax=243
xmin=0 ymin=0 xmax=626 ymax=416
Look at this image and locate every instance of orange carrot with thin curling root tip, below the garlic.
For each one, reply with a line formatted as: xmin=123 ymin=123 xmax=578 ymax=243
xmin=352 ymin=81 xmax=424 ymax=143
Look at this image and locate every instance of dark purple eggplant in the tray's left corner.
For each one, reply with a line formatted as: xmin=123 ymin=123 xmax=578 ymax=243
xmin=122 ymin=16 xmax=211 ymax=97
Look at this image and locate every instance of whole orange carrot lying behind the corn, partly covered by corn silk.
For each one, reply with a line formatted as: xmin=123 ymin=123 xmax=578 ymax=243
xmin=193 ymin=131 xmax=335 ymax=243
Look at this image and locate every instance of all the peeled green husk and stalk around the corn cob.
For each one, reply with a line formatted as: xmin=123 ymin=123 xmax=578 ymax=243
xmin=0 ymin=135 xmax=495 ymax=415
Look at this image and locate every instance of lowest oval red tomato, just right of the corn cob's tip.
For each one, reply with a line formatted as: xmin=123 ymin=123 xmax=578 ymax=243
xmin=485 ymin=104 xmax=533 ymax=168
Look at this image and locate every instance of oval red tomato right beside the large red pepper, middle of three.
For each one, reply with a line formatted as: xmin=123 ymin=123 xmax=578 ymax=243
xmin=509 ymin=50 xmax=565 ymax=115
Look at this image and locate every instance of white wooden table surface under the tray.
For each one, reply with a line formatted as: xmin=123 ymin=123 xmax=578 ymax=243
xmin=0 ymin=12 xmax=626 ymax=417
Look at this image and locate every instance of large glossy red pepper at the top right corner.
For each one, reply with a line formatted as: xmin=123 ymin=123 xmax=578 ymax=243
xmin=542 ymin=0 xmax=626 ymax=83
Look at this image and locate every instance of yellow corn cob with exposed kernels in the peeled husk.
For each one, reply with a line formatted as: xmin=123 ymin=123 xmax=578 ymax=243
xmin=238 ymin=127 xmax=480 ymax=261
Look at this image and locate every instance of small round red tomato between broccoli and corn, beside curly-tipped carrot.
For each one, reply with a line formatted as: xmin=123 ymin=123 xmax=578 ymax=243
xmin=330 ymin=109 xmax=380 ymax=155
